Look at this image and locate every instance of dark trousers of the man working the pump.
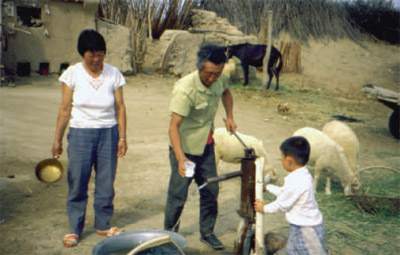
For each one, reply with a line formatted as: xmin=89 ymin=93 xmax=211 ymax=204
xmin=164 ymin=144 xmax=219 ymax=235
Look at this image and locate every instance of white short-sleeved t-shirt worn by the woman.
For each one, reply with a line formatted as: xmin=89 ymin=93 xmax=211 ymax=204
xmin=59 ymin=63 xmax=126 ymax=128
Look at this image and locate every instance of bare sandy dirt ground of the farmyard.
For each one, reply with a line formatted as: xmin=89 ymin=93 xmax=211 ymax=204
xmin=0 ymin=40 xmax=400 ymax=255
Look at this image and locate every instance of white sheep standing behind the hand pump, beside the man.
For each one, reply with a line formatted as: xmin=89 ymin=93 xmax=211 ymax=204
xmin=213 ymin=128 xmax=277 ymax=182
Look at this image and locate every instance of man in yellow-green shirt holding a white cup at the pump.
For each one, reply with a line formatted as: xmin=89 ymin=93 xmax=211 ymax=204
xmin=164 ymin=44 xmax=236 ymax=250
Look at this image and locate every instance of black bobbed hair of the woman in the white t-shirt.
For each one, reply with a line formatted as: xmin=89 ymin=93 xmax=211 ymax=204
xmin=78 ymin=29 xmax=106 ymax=57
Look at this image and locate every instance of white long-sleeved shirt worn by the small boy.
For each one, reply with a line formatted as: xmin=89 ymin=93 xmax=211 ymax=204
xmin=264 ymin=167 xmax=323 ymax=226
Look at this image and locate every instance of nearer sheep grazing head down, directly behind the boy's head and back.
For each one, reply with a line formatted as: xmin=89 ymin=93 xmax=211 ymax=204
xmin=293 ymin=127 xmax=361 ymax=195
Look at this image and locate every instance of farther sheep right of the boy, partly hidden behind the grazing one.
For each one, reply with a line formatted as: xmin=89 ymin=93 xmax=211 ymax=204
xmin=322 ymin=120 xmax=360 ymax=172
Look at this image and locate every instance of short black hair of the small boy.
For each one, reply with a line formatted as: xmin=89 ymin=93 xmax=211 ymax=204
xmin=280 ymin=136 xmax=310 ymax=166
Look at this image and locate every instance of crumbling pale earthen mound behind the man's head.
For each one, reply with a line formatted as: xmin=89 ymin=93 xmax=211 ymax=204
xmin=144 ymin=10 xmax=258 ymax=77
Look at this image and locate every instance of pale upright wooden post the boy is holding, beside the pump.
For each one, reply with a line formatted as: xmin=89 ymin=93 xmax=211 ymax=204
xmin=255 ymin=157 xmax=265 ymax=255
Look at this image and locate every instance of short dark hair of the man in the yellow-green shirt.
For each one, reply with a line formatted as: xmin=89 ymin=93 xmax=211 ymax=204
xmin=196 ymin=44 xmax=226 ymax=70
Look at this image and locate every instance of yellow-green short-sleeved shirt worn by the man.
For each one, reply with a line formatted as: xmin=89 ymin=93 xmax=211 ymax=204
xmin=170 ymin=71 xmax=229 ymax=155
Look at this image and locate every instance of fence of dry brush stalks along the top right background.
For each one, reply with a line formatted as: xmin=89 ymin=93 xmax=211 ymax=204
xmin=205 ymin=0 xmax=358 ymax=43
